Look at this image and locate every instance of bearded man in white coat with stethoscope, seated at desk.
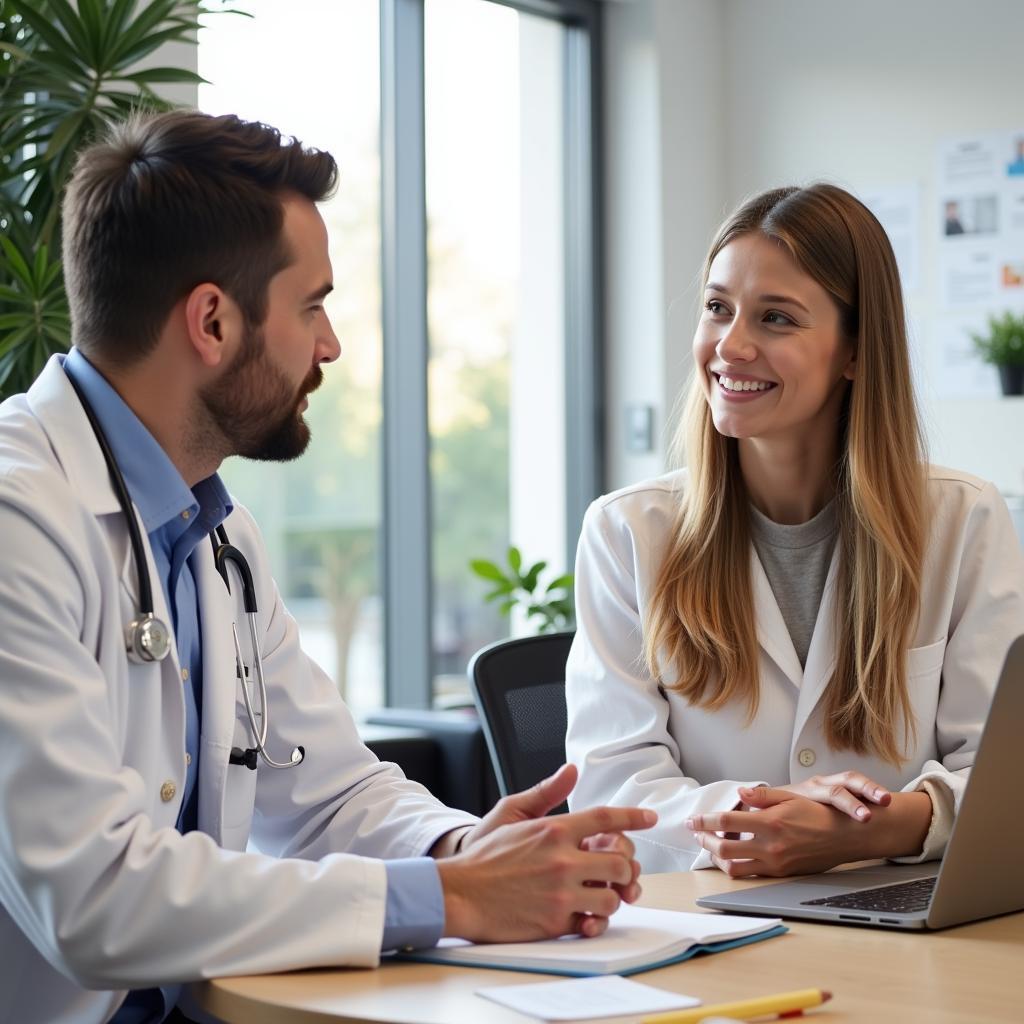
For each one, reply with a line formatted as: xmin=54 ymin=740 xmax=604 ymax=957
xmin=0 ymin=112 xmax=654 ymax=1024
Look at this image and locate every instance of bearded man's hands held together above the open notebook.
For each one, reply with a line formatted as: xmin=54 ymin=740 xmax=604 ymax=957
xmin=437 ymin=765 xmax=657 ymax=942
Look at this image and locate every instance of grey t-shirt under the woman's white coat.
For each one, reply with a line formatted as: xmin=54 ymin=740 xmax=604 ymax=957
xmin=751 ymin=501 xmax=836 ymax=666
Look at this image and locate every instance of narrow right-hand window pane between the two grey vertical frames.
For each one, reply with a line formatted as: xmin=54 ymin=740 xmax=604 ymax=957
xmin=424 ymin=0 xmax=566 ymax=700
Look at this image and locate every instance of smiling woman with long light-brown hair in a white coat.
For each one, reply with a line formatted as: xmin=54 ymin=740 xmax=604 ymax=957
xmin=566 ymin=184 xmax=1024 ymax=877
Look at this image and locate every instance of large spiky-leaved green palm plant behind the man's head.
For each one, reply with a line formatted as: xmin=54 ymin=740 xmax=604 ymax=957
xmin=0 ymin=0 xmax=220 ymax=398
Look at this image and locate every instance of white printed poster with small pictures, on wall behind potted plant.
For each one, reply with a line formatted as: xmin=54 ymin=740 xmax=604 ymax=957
xmin=933 ymin=128 xmax=1024 ymax=397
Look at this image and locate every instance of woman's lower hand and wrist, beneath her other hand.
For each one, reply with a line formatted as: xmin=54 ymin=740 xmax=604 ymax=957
xmin=686 ymin=786 xmax=932 ymax=878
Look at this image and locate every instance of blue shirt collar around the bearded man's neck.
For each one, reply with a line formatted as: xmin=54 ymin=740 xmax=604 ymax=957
xmin=63 ymin=348 xmax=231 ymax=534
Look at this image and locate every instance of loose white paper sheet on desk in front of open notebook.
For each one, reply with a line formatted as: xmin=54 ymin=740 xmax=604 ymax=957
xmin=476 ymin=975 xmax=700 ymax=1021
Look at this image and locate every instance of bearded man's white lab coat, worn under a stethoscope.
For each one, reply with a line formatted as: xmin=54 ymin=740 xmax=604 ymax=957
xmin=0 ymin=359 xmax=476 ymax=1024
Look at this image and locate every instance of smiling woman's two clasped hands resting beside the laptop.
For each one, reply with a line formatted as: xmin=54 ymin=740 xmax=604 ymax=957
xmin=685 ymin=771 xmax=931 ymax=878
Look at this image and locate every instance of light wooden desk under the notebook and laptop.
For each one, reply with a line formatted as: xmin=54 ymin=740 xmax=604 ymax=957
xmin=194 ymin=871 xmax=1024 ymax=1024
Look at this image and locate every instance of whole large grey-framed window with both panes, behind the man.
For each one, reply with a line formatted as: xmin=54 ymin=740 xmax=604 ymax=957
xmin=199 ymin=0 xmax=601 ymax=715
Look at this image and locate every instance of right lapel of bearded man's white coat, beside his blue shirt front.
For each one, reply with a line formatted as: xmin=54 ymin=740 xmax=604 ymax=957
xmin=193 ymin=544 xmax=237 ymax=843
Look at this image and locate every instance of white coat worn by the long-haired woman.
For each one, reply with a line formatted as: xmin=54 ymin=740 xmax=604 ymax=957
xmin=566 ymin=467 xmax=1024 ymax=871
